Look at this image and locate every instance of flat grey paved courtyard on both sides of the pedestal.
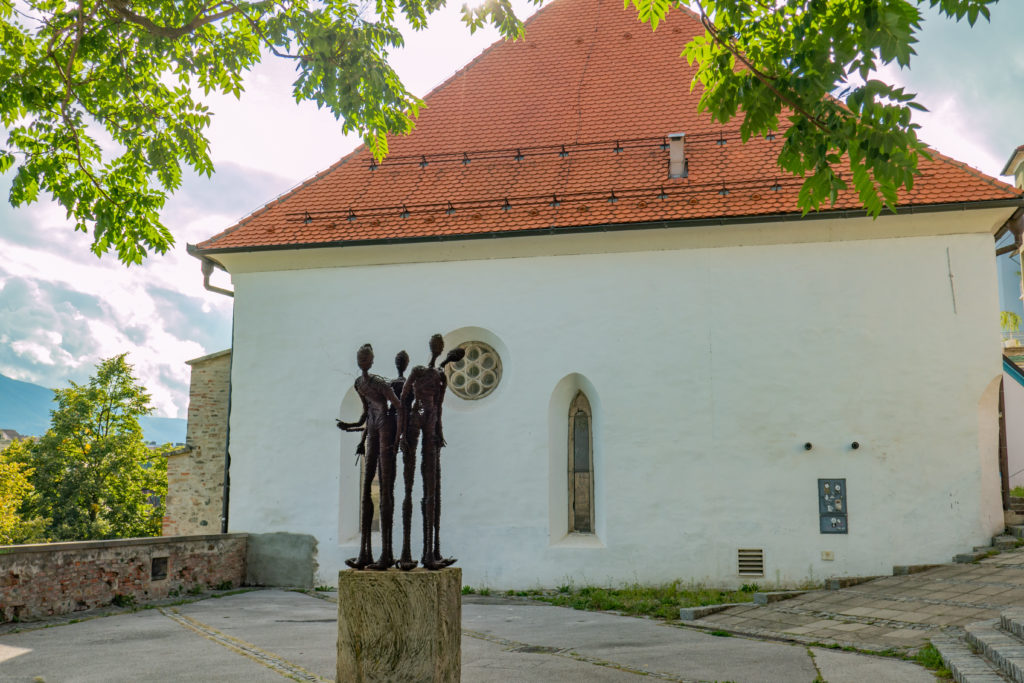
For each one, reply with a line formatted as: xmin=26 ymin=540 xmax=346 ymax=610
xmin=0 ymin=590 xmax=934 ymax=683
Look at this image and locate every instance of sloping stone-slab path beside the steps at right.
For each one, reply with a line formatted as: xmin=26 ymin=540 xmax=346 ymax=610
xmin=691 ymin=548 xmax=1024 ymax=650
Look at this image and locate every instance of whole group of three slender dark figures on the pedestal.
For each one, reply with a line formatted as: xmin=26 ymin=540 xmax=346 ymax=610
xmin=337 ymin=335 xmax=466 ymax=571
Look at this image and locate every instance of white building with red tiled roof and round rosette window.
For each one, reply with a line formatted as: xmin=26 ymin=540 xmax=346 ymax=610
xmin=191 ymin=0 xmax=1021 ymax=588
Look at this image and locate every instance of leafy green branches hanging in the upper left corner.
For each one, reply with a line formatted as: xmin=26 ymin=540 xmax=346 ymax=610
xmin=0 ymin=0 xmax=540 ymax=264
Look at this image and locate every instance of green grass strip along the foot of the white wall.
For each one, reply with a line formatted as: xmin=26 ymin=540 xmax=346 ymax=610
xmin=536 ymin=581 xmax=754 ymax=620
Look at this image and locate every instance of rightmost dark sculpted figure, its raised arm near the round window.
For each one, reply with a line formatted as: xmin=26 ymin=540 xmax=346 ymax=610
xmin=401 ymin=335 xmax=466 ymax=569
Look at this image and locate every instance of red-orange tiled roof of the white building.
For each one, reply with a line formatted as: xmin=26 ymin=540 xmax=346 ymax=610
xmin=194 ymin=0 xmax=1021 ymax=252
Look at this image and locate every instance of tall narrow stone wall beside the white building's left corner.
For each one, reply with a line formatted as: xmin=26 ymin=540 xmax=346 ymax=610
xmin=163 ymin=349 xmax=231 ymax=536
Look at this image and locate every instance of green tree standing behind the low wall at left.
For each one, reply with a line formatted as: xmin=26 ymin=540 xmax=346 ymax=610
xmin=12 ymin=354 xmax=167 ymax=541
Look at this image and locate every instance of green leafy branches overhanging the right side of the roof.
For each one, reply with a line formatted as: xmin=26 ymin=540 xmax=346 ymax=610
xmin=626 ymin=0 xmax=998 ymax=216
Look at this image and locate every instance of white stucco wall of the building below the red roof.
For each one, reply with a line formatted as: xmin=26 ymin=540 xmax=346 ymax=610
xmin=223 ymin=213 xmax=1002 ymax=589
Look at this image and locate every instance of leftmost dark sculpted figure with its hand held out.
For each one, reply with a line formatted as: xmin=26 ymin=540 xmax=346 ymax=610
xmin=337 ymin=344 xmax=404 ymax=571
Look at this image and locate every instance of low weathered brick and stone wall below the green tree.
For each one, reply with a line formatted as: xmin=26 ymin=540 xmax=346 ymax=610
xmin=0 ymin=533 xmax=247 ymax=622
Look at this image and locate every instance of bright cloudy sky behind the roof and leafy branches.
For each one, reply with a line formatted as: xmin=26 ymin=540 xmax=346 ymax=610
xmin=0 ymin=0 xmax=1024 ymax=419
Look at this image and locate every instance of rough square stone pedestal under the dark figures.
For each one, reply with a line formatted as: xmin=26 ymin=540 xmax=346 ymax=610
xmin=337 ymin=567 xmax=462 ymax=683
